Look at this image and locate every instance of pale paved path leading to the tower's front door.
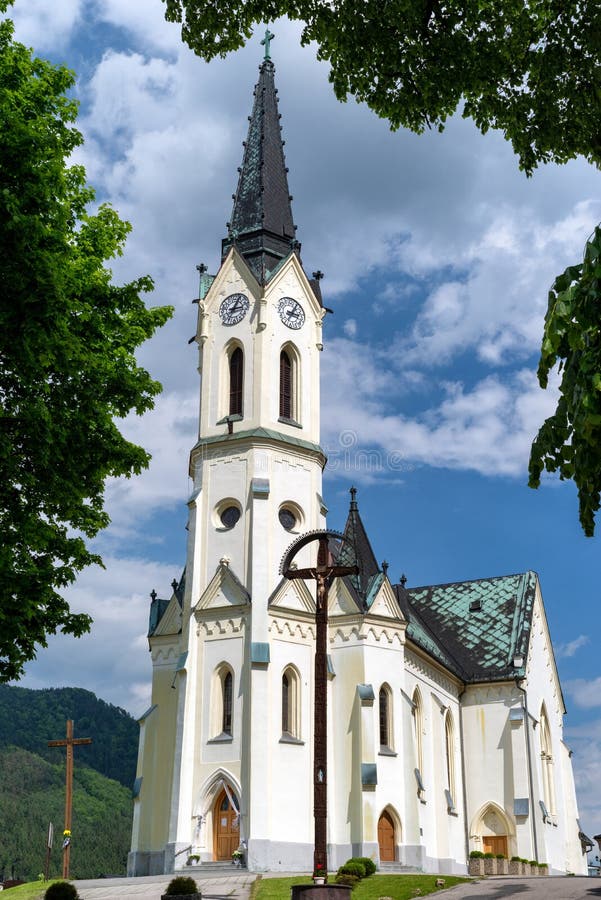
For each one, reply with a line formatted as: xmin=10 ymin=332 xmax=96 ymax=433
xmin=74 ymin=872 xmax=257 ymax=900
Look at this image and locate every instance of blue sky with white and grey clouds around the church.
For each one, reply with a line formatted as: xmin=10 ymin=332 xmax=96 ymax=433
xmin=12 ymin=0 xmax=601 ymax=834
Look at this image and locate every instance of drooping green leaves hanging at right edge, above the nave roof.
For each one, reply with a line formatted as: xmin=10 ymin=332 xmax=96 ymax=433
xmin=529 ymin=226 xmax=601 ymax=537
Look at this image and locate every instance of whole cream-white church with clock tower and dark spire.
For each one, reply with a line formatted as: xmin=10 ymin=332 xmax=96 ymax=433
xmin=128 ymin=42 xmax=587 ymax=875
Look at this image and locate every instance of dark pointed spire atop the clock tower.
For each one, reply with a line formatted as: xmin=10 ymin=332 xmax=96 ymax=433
xmin=222 ymin=31 xmax=300 ymax=284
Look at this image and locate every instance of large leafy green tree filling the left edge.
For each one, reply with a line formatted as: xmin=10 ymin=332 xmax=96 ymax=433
xmin=0 ymin=8 xmax=171 ymax=681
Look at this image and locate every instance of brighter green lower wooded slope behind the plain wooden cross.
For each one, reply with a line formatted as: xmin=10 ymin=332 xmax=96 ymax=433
xmin=0 ymin=747 xmax=132 ymax=879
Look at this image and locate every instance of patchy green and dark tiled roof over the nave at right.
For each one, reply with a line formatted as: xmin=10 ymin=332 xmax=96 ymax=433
xmin=395 ymin=572 xmax=537 ymax=682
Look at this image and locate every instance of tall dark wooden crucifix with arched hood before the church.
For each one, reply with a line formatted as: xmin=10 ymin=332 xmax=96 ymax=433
xmin=281 ymin=531 xmax=359 ymax=883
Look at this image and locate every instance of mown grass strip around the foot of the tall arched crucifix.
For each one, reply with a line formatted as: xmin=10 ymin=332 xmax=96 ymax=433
xmin=251 ymin=875 xmax=470 ymax=900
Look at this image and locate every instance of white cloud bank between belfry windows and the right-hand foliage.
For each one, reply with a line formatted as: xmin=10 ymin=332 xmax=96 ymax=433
xmin=322 ymin=339 xmax=556 ymax=476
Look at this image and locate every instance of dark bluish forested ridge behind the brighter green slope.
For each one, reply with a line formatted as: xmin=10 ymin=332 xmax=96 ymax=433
xmin=0 ymin=684 xmax=138 ymax=789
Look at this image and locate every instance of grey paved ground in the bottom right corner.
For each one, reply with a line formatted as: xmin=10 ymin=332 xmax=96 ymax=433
xmin=441 ymin=876 xmax=601 ymax=900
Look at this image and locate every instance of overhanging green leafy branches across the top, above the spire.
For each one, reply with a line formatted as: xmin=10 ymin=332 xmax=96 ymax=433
xmin=164 ymin=0 xmax=601 ymax=172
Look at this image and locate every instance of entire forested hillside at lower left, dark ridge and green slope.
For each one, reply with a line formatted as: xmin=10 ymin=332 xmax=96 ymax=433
xmin=0 ymin=684 xmax=138 ymax=881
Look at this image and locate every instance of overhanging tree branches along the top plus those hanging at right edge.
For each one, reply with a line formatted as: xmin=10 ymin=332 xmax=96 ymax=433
xmin=164 ymin=0 xmax=601 ymax=535
